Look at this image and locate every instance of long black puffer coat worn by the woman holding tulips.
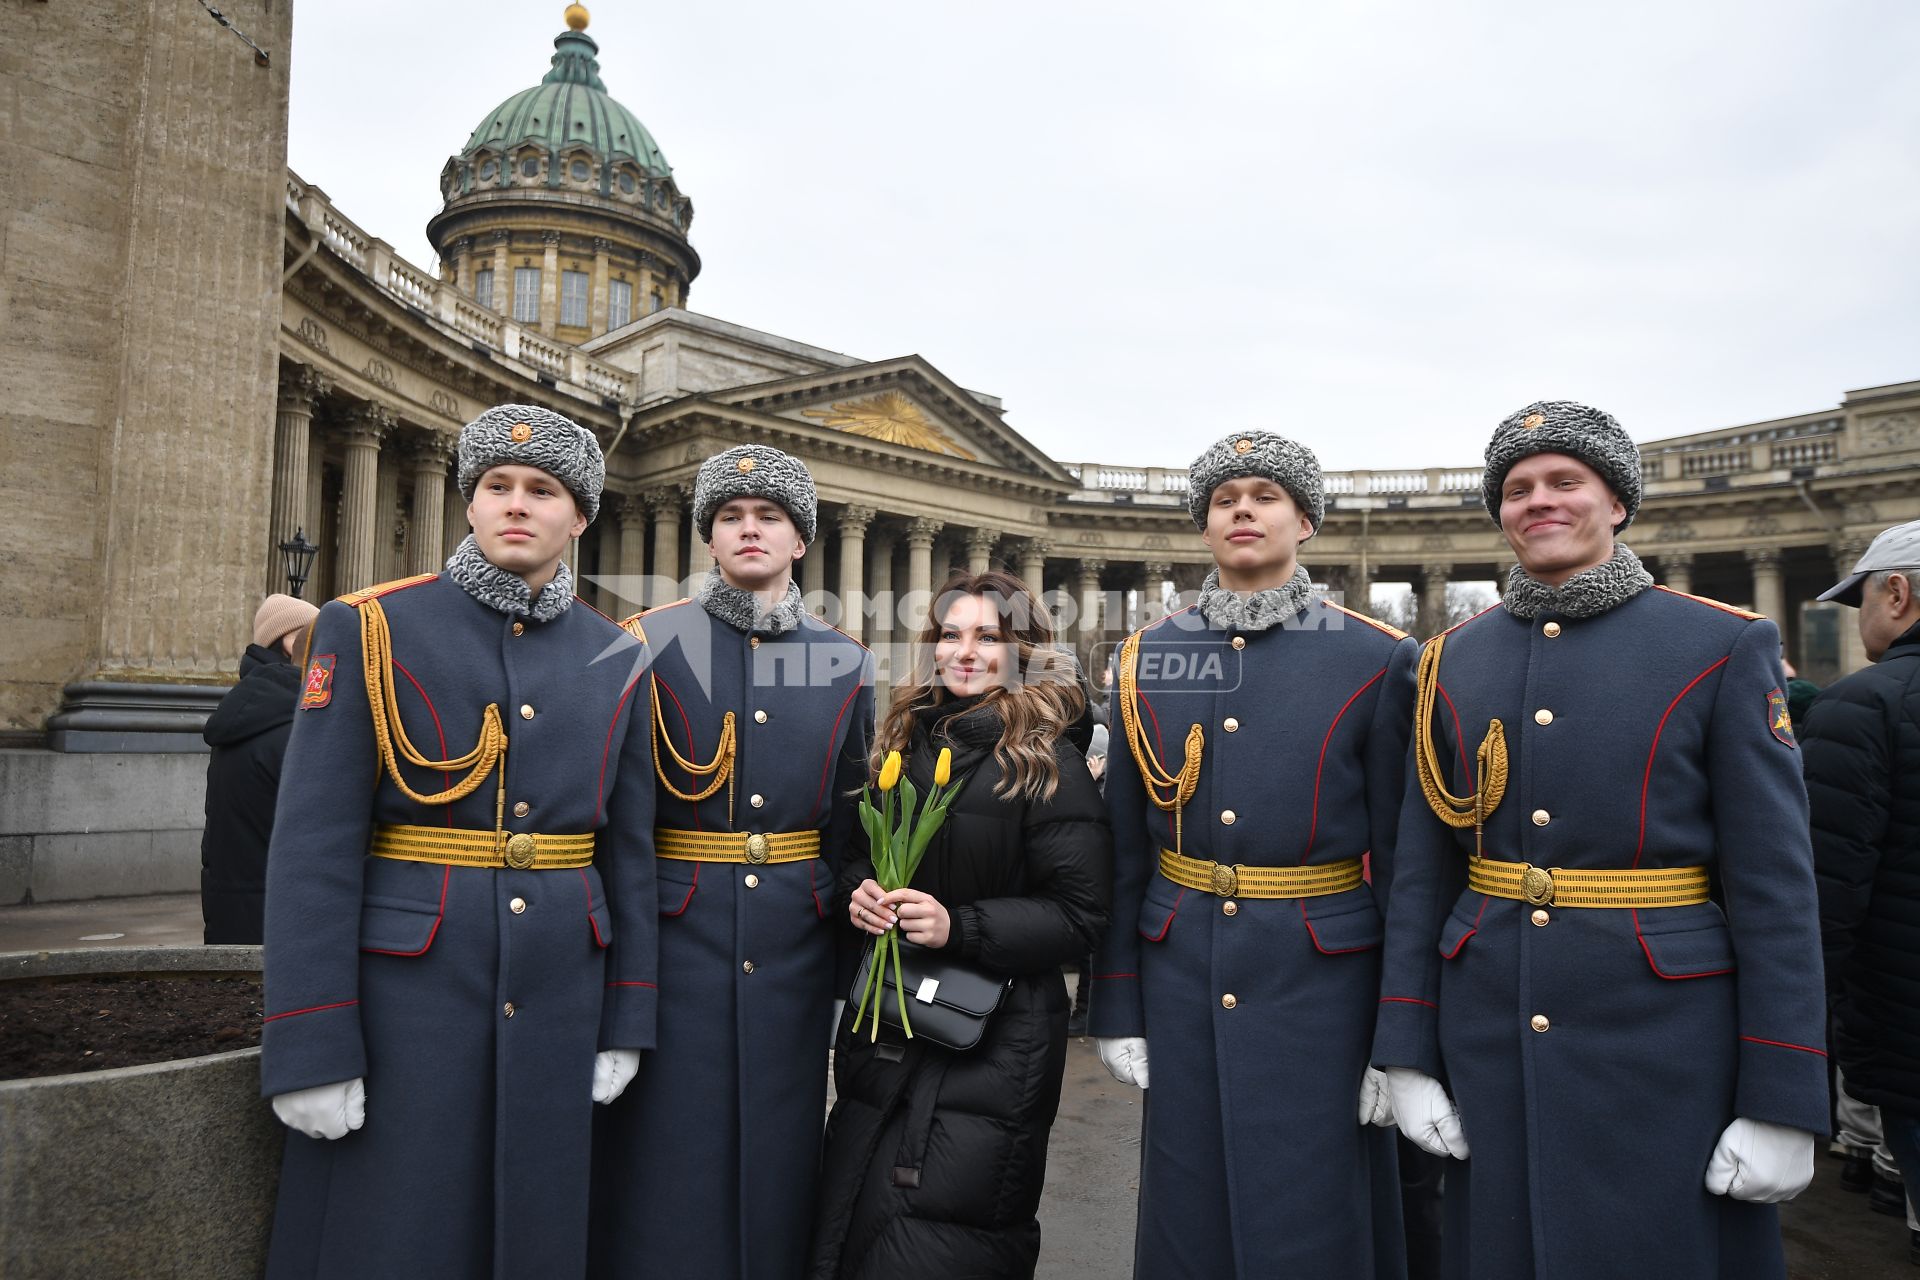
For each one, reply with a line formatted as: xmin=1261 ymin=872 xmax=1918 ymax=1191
xmin=808 ymin=702 xmax=1114 ymax=1280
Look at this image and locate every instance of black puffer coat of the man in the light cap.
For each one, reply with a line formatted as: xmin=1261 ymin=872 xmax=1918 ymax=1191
xmin=1801 ymin=626 xmax=1920 ymax=1115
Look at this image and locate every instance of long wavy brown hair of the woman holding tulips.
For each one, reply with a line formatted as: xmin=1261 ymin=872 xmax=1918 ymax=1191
xmin=874 ymin=570 xmax=1087 ymax=800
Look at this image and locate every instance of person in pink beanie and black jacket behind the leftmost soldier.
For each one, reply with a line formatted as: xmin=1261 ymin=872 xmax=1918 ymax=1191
xmin=200 ymin=595 xmax=321 ymax=944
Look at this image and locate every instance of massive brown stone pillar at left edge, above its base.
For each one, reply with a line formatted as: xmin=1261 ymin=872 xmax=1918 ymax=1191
xmin=0 ymin=0 xmax=292 ymax=731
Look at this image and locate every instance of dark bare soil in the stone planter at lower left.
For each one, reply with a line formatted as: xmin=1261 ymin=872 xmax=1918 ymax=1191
xmin=0 ymin=973 xmax=263 ymax=1080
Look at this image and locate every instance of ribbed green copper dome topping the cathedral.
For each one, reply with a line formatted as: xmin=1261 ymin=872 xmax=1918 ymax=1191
xmin=459 ymin=31 xmax=674 ymax=186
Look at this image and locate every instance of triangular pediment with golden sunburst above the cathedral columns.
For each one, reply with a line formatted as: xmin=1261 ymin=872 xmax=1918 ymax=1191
xmin=705 ymin=355 xmax=1071 ymax=482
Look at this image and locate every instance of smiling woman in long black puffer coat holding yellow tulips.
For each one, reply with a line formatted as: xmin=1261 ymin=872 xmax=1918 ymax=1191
xmin=808 ymin=572 xmax=1114 ymax=1280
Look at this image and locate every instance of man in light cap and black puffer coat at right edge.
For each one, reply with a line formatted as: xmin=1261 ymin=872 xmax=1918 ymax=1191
xmin=1801 ymin=520 xmax=1920 ymax=1261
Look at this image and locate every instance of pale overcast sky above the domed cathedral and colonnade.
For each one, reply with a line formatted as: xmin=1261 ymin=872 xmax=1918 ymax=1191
xmin=288 ymin=0 xmax=1920 ymax=468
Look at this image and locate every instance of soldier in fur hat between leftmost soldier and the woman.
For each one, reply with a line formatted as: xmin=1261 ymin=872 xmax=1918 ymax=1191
xmin=591 ymin=445 xmax=874 ymax=1280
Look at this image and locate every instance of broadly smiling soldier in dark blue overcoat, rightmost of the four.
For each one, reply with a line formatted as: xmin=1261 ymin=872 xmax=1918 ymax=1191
xmin=1375 ymin=401 xmax=1828 ymax=1280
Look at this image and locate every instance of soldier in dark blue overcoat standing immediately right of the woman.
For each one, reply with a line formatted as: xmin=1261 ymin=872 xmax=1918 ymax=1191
xmin=1091 ymin=432 xmax=1415 ymax=1280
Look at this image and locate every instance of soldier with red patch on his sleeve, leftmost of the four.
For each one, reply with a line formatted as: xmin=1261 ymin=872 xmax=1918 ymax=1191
xmin=261 ymin=405 xmax=657 ymax=1278
